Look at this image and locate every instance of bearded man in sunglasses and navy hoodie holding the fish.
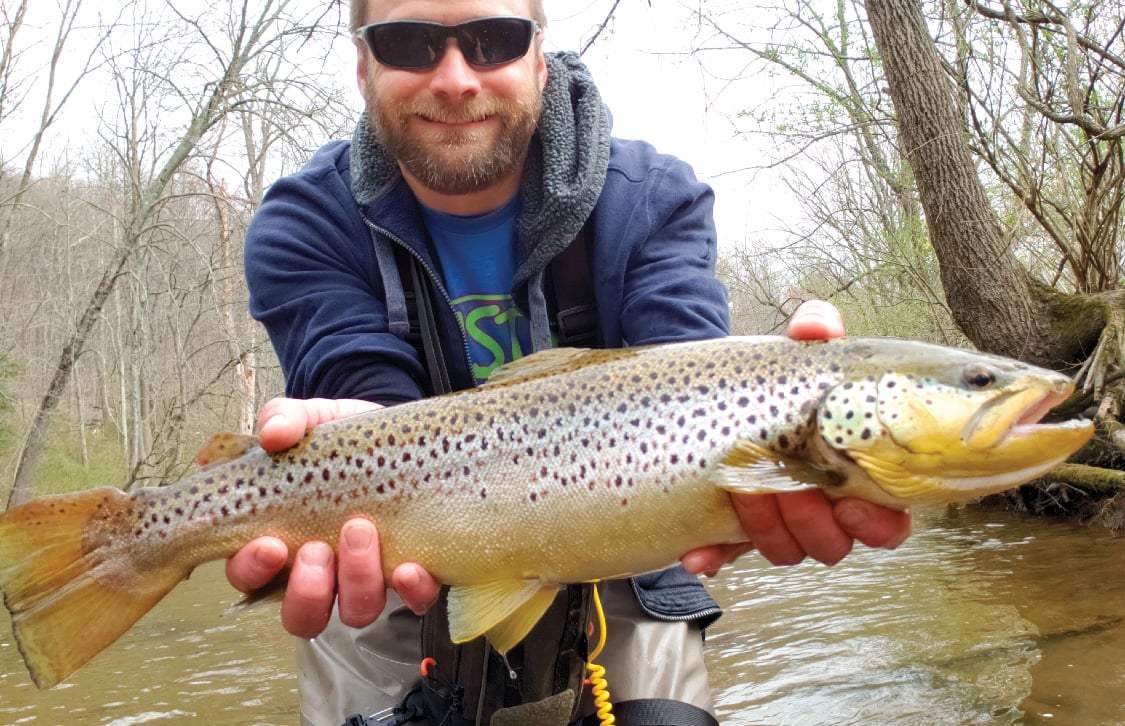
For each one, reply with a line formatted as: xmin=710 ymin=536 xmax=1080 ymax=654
xmin=227 ymin=0 xmax=910 ymax=726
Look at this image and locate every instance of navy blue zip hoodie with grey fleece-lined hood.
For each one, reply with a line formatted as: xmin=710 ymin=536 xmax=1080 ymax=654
xmin=245 ymin=53 xmax=728 ymax=624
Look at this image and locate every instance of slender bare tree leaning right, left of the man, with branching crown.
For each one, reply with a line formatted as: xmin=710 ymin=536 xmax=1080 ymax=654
xmin=9 ymin=0 xmax=344 ymax=502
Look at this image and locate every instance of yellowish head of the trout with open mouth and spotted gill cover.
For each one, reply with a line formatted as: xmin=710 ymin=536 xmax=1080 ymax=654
xmin=818 ymin=344 xmax=1094 ymax=507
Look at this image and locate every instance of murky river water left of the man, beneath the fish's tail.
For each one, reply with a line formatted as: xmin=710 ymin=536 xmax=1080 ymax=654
xmin=0 ymin=563 xmax=299 ymax=726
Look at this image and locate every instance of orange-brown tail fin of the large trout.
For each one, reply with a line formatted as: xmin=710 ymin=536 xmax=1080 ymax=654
xmin=0 ymin=487 xmax=188 ymax=688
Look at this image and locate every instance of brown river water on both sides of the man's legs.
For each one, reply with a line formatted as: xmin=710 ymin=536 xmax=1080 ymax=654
xmin=0 ymin=510 xmax=1125 ymax=726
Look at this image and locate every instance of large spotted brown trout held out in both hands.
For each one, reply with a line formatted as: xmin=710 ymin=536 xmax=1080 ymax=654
xmin=0 ymin=337 xmax=1094 ymax=688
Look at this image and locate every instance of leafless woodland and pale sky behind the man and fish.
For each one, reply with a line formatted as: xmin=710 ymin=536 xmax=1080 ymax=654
xmin=0 ymin=0 xmax=1125 ymax=528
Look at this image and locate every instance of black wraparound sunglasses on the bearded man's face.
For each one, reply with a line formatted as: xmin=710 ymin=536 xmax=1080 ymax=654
xmin=356 ymin=17 xmax=539 ymax=71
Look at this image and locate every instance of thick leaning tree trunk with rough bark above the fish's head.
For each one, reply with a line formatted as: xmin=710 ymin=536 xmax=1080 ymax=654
xmin=866 ymin=0 xmax=1101 ymax=368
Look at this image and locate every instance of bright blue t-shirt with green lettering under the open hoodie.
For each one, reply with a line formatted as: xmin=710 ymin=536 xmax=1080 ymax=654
xmin=422 ymin=197 xmax=531 ymax=383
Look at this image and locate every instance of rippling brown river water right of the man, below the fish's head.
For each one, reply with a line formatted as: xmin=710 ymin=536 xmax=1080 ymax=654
xmin=710 ymin=511 xmax=1125 ymax=726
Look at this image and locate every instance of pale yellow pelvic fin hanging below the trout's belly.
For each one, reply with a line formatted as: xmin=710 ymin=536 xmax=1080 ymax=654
xmin=449 ymin=580 xmax=558 ymax=653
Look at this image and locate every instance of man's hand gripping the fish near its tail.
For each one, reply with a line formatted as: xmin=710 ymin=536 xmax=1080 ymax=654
xmin=226 ymin=398 xmax=440 ymax=638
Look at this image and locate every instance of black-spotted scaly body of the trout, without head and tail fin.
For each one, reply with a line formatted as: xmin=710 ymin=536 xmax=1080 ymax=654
xmin=107 ymin=337 xmax=840 ymax=584
